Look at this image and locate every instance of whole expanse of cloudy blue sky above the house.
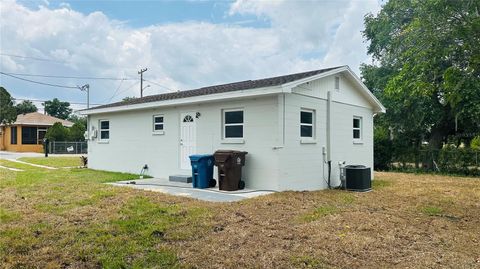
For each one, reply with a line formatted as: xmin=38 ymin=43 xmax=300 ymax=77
xmin=0 ymin=0 xmax=380 ymax=109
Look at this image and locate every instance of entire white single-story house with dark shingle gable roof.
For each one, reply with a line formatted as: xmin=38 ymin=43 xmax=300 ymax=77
xmin=82 ymin=66 xmax=385 ymax=190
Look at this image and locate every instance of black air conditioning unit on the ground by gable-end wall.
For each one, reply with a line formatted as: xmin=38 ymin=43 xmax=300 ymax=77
xmin=345 ymin=165 xmax=372 ymax=191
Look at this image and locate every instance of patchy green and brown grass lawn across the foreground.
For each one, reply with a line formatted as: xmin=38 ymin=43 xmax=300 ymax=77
xmin=0 ymin=160 xmax=480 ymax=268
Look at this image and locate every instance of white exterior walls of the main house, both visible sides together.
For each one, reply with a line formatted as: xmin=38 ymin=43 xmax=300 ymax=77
xmin=89 ymin=74 xmax=374 ymax=190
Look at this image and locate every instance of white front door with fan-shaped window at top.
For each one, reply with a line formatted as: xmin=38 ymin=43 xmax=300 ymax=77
xmin=180 ymin=112 xmax=197 ymax=170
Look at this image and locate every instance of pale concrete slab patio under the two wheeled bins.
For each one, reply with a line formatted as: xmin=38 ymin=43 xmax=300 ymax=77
xmin=107 ymin=178 xmax=274 ymax=202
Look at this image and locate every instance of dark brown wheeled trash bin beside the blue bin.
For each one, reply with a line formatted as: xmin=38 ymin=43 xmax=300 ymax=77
xmin=213 ymin=150 xmax=248 ymax=191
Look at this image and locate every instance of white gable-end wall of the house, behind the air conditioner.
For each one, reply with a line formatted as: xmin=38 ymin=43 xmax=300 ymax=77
xmin=279 ymin=73 xmax=373 ymax=190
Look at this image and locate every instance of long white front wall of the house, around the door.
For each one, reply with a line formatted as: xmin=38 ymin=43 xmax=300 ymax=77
xmin=88 ymin=95 xmax=278 ymax=189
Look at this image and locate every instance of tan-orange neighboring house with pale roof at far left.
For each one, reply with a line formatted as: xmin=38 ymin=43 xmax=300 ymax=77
xmin=0 ymin=112 xmax=73 ymax=152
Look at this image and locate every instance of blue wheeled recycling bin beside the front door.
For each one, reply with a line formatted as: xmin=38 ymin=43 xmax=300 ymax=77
xmin=190 ymin=154 xmax=217 ymax=189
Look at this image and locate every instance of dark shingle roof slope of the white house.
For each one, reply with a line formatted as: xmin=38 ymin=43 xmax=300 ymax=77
xmin=91 ymin=66 xmax=342 ymax=109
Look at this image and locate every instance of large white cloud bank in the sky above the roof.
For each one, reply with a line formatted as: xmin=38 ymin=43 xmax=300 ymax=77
xmin=0 ymin=0 xmax=379 ymax=103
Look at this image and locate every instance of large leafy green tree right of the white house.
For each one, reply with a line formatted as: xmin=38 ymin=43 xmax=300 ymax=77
xmin=362 ymin=0 xmax=480 ymax=148
